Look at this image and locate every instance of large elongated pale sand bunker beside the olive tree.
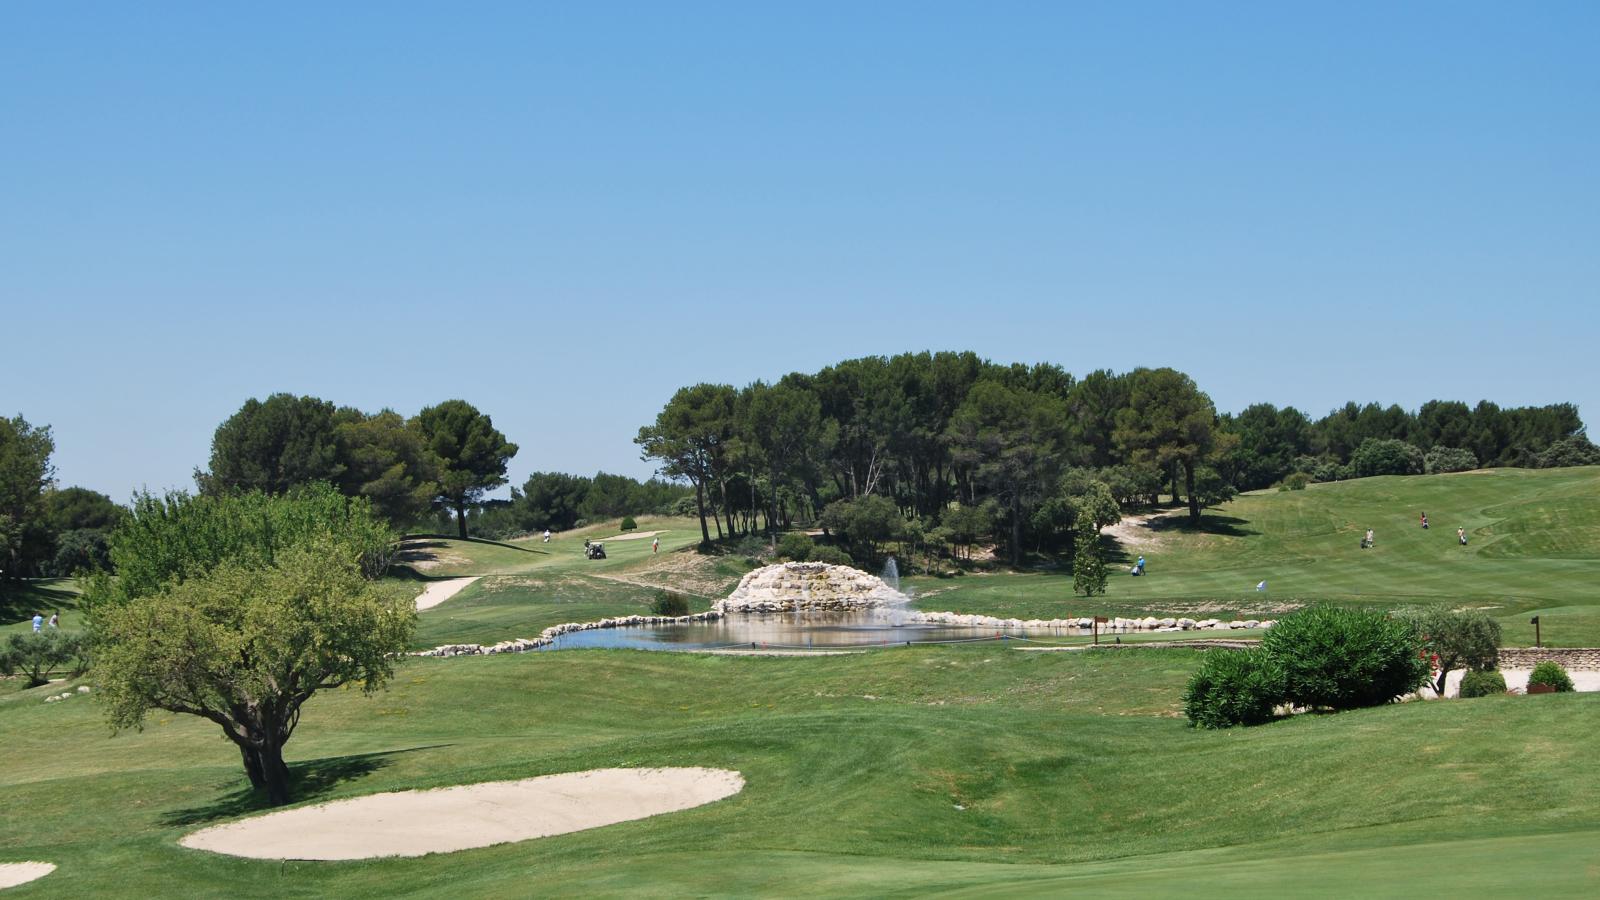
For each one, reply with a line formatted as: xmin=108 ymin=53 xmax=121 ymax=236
xmin=179 ymin=767 xmax=744 ymax=860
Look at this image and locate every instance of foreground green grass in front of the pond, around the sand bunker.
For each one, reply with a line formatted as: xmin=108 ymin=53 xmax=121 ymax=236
xmin=0 ymin=645 xmax=1600 ymax=897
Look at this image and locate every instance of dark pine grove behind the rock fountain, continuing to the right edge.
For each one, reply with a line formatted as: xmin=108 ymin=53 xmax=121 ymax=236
xmin=635 ymin=352 xmax=1600 ymax=560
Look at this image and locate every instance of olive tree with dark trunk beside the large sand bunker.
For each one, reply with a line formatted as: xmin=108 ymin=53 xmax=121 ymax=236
xmin=93 ymin=535 xmax=416 ymax=806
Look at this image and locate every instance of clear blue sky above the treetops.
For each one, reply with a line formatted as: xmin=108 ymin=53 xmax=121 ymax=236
xmin=0 ymin=2 xmax=1600 ymax=500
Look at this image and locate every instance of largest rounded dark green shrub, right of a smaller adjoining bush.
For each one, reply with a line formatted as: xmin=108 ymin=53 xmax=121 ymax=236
xmin=1261 ymin=605 xmax=1429 ymax=709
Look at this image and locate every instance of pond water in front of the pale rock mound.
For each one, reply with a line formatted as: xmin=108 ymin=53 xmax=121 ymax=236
xmin=544 ymin=610 xmax=1088 ymax=650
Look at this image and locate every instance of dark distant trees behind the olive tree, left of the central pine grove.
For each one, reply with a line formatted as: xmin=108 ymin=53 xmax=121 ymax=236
xmin=0 ymin=394 xmax=688 ymax=581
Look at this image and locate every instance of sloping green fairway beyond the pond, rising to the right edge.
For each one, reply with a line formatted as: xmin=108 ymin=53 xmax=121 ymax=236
xmin=907 ymin=466 xmax=1600 ymax=647
